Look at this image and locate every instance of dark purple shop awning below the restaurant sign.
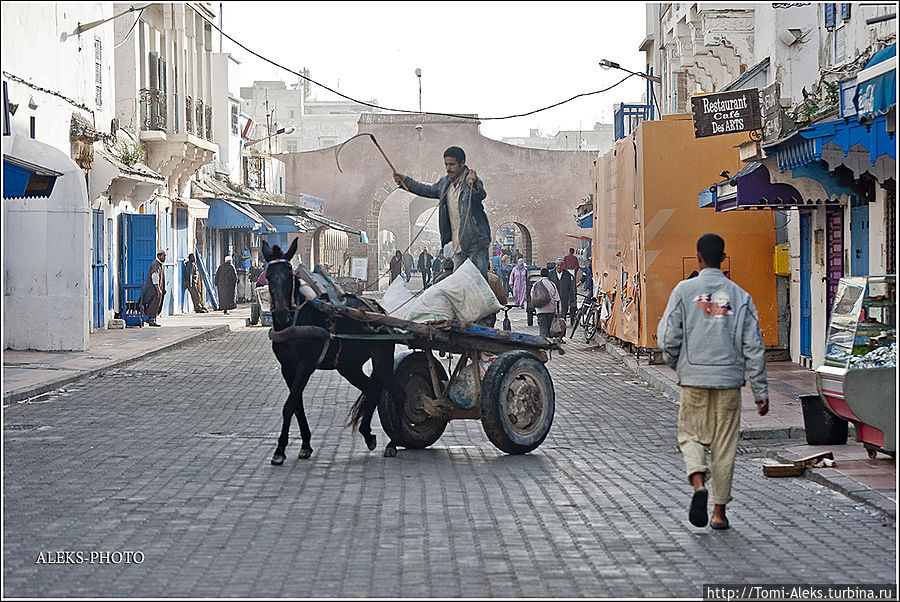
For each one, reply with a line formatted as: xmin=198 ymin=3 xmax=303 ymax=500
xmin=715 ymin=163 xmax=806 ymax=211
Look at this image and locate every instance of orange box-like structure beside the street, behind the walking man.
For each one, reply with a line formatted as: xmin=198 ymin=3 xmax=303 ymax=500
xmin=592 ymin=115 xmax=778 ymax=348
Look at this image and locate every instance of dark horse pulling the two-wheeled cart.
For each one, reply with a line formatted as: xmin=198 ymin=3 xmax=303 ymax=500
xmin=262 ymin=240 xmax=403 ymax=465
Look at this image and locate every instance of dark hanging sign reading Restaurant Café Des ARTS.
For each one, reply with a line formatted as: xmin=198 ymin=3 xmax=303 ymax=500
xmin=691 ymin=88 xmax=762 ymax=138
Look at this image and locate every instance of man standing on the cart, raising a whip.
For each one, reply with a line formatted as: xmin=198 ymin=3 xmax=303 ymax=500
xmin=394 ymin=146 xmax=491 ymax=280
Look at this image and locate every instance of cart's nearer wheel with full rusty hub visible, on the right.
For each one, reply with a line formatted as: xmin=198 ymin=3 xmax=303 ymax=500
xmin=481 ymin=350 xmax=556 ymax=454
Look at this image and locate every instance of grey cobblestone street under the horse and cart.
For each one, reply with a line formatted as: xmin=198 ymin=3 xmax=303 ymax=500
xmin=3 ymin=310 xmax=896 ymax=598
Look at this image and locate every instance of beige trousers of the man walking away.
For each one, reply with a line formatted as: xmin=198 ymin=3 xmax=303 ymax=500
xmin=678 ymin=387 xmax=741 ymax=504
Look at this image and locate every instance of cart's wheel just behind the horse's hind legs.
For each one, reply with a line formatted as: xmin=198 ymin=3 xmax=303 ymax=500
xmin=378 ymin=351 xmax=449 ymax=449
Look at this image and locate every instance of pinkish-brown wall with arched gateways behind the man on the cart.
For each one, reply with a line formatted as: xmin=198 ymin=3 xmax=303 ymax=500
xmin=278 ymin=113 xmax=595 ymax=288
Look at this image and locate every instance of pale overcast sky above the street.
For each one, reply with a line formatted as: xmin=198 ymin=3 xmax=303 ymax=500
xmin=221 ymin=2 xmax=646 ymax=139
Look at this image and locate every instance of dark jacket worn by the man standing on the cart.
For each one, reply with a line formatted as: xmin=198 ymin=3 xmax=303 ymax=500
xmin=404 ymin=167 xmax=491 ymax=254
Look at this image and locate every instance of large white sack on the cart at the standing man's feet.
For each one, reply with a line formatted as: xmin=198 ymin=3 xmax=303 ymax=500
xmin=406 ymin=259 xmax=503 ymax=322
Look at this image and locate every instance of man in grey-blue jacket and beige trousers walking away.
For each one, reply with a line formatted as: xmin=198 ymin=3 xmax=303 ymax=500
xmin=657 ymin=234 xmax=769 ymax=530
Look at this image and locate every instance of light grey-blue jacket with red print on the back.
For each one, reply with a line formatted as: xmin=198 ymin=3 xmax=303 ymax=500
xmin=657 ymin=268 xmax=769 ymax=401
